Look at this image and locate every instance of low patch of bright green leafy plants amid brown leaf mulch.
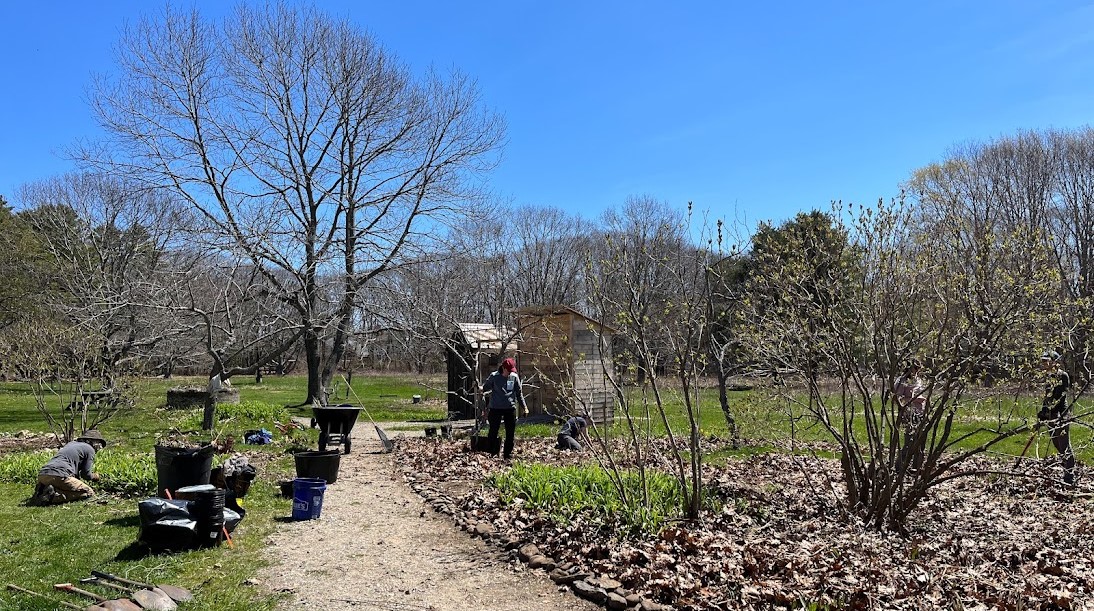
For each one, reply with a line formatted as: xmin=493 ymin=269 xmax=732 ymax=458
xmin=490 ymin=462 xmax=682 ymax=532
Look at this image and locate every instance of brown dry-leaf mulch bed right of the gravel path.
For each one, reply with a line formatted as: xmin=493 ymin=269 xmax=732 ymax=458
xmin=397 ymin=439 xmax=1094 ymax=611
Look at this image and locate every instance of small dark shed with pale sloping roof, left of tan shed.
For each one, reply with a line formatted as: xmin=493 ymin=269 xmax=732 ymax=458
xmin=445 ymin=322 xmax=520 ymax=420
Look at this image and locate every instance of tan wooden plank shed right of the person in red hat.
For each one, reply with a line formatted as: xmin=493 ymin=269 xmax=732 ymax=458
xmin=515 ymin=306 xmax=615 ymax=424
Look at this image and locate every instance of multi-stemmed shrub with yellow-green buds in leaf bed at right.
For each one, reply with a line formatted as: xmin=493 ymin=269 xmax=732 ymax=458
xmin=741 ymin=202 xmax=1076 ymax=530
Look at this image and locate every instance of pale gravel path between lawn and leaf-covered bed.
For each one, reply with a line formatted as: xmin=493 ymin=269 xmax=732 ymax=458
xmin=259 ymin=423 xmax=601 ymax=611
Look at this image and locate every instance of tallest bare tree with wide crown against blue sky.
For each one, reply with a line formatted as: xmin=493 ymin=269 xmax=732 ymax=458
xmin=80 ymin=3 xmax=503 ymax=402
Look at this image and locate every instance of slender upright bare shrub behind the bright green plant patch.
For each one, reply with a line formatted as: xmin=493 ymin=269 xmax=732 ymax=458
xmin=586 ymin=198 xmax=712 ymax=519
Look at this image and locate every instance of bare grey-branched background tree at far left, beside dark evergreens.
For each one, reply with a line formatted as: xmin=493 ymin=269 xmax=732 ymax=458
xmin=20 ymin=174 xmax=188 ymax=380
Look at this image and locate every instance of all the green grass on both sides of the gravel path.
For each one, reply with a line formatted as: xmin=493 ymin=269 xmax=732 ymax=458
xmin=0 ymin=375 xmax=1094 ymax=611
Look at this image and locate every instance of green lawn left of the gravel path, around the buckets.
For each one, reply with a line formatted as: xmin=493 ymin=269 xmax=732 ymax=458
xmin=0 ymin=376 xmax=445 ymax=611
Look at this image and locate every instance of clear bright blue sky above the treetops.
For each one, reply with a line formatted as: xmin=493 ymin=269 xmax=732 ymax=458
xmin=0 ymin=0 xmax=1094 ymax=227
